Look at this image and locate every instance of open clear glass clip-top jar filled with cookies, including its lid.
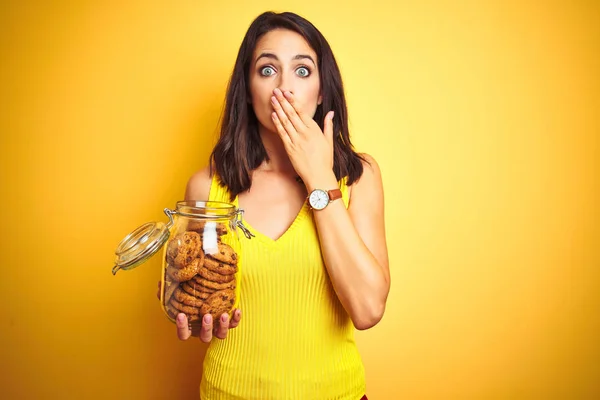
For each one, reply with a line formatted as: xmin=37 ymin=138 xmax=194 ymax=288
xmin=112 ymin=201 xmax=253 ymax=325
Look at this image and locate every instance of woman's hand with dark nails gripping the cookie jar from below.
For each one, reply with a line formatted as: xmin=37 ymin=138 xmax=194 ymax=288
xmin=157 ymin=281 xmax=242 ymax=343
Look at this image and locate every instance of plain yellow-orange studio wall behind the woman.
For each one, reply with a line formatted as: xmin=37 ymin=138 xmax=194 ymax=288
xmin=0 ymin=0 xmax=600 ymax=399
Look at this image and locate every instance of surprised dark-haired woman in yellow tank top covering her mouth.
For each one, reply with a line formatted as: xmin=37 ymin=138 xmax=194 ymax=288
xmin=177 ymin=12 xmax=390 ymax=400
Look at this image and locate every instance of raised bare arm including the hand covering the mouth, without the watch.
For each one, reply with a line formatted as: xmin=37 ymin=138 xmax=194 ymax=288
xmin=271 ymin=89 xmax=390 ymax=329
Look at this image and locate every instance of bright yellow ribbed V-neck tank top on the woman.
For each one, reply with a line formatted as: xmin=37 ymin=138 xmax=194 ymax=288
xmin=200 ymin=176 xmax=365 ymax=400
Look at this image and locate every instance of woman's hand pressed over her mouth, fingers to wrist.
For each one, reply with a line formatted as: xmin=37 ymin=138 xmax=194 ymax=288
xmin=271 ymin=89 xmax=333 ymax=183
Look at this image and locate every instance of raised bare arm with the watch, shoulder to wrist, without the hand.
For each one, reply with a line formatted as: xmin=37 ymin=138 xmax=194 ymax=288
xmin=307 ymin=156 xmax=390 ymax=330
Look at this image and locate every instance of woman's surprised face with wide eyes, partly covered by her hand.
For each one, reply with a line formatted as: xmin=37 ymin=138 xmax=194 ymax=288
xmin=249 ymin=29 xmax=321 ymax=132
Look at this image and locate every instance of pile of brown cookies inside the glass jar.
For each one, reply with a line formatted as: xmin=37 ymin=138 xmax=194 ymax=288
xmin=163 ymin=221 xmax=238 ymax=322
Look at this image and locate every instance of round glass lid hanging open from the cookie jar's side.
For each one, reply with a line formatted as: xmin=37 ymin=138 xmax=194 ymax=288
xmin=112 ymin=222 xmax=171 ymax=275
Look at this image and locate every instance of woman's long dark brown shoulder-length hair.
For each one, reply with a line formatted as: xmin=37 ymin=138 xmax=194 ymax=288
xmin=210 ymin=12 xmax=364 ymax=200
